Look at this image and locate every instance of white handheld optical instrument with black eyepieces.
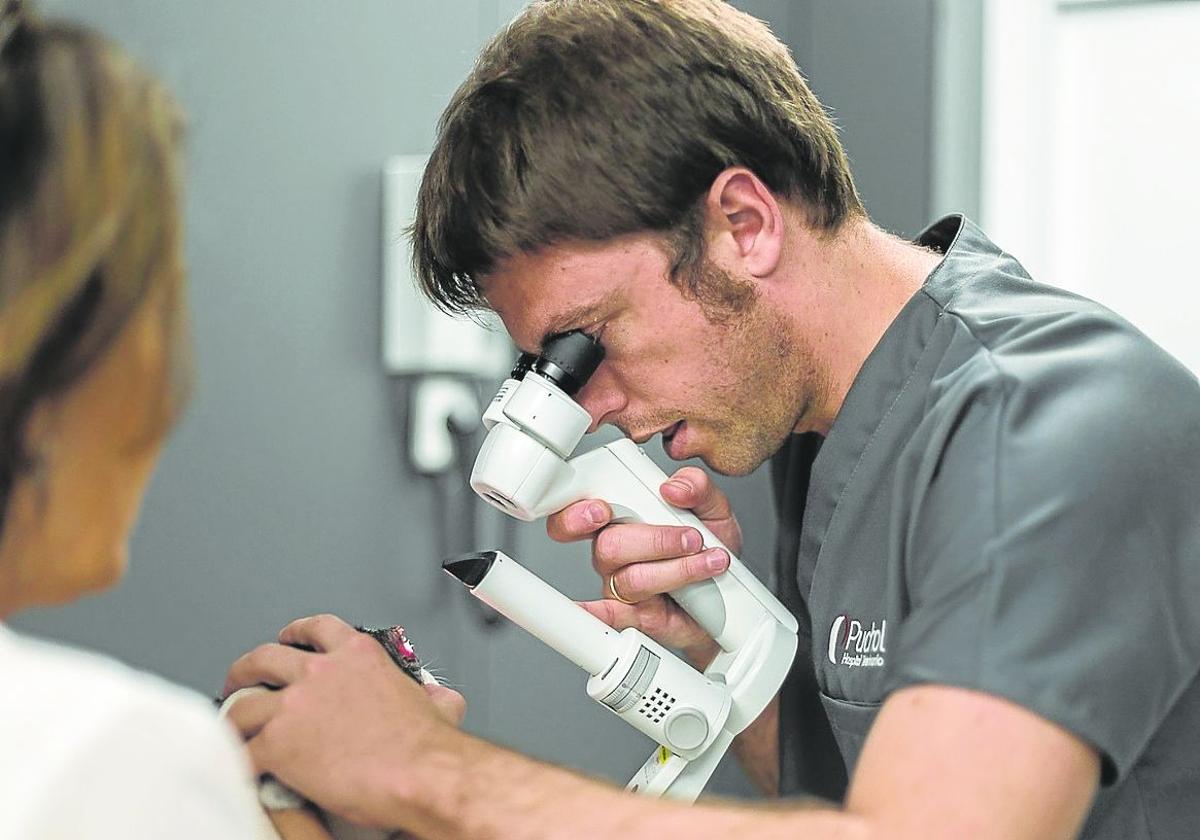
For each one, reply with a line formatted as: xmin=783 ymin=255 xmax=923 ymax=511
xmin=458 ymin=331 xmax=797 ymax=800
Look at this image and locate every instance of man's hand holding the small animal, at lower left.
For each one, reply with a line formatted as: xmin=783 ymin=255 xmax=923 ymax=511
xmin=226 ymin=616 xmax=466 ymax=827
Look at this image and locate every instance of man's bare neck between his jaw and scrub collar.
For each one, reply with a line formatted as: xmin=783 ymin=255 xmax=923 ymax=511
xmin=793 ymin=213 xmax=941 ymax=434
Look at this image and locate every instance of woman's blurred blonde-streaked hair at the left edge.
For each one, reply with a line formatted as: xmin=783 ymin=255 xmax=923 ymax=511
xmin=0 ymin=0 xmax=184 ymax=515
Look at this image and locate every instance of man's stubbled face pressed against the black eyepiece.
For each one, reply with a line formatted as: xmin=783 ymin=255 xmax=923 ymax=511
xmin=484 ymin=234 xmax=811 ymax=475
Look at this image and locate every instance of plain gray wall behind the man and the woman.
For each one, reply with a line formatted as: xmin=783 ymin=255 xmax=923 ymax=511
xmin=14 ymin=0 xmax=945 ymax=793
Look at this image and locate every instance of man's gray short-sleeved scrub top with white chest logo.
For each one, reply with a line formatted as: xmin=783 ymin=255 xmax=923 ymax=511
xmin=772 ymin=216 xmax=1200 ymax=840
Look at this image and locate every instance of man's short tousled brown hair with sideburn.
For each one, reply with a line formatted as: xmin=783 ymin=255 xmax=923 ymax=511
xmin=410 ymin=0 xmax=864 ymax=313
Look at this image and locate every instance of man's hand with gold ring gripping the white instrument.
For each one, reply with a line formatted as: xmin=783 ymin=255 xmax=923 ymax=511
xmin=546 ymin=467 xmax=742 ymax=668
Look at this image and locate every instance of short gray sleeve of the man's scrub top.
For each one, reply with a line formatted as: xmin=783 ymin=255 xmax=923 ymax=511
xmin=888 ymin=336 xmax=1200 ymax=784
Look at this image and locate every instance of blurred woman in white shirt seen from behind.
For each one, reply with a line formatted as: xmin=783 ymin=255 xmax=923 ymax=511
xmin=0 ymin=0 xmax=338 ymax=840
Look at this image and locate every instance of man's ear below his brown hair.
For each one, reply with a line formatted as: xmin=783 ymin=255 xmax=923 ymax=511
xmin=704 ymin=167 xmax=784 ymax=277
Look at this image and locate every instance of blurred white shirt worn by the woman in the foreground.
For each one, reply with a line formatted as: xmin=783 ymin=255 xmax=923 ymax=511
xmin=0 ymin=625 xmax=276 ymax=840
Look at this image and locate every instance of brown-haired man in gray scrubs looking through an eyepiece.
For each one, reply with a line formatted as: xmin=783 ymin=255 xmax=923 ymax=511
xmin=220 ymin=0 xmax=1200 ymax=839
